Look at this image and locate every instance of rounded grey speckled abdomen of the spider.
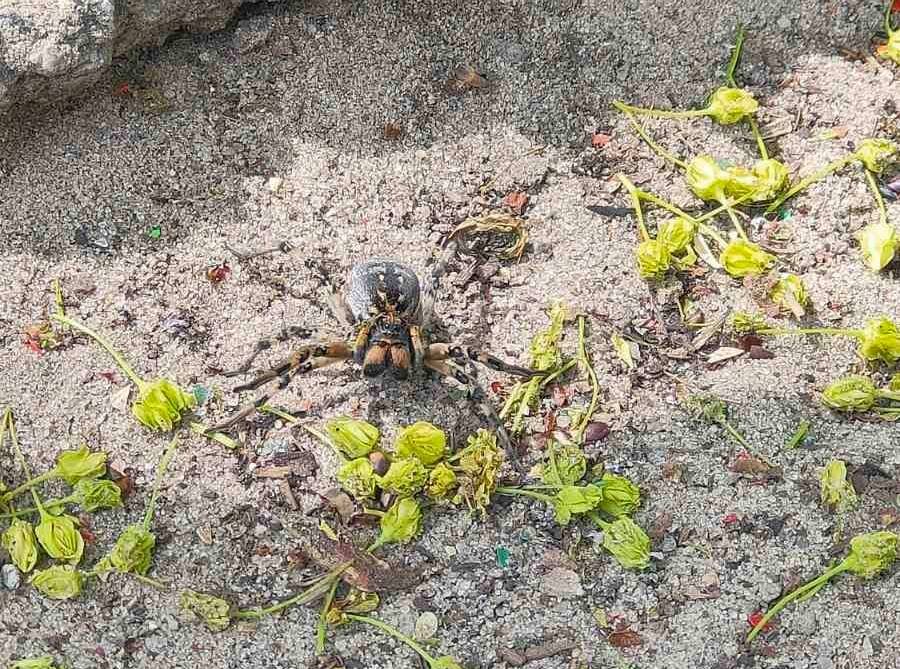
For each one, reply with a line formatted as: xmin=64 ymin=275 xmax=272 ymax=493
xmin=345 ymin=260 xmax=420 ymax=323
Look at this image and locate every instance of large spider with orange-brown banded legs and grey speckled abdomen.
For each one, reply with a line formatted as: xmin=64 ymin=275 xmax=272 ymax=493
xmin=209 ymin=260 xmax=545 ymax=458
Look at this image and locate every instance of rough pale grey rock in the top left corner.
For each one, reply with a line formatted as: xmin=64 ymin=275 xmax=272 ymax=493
xmin=0 ymin=0 xmax=270 ymax=110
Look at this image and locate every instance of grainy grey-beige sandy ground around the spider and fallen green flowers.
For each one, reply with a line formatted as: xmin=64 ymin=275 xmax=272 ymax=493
xmin=0 ymin=0 xmax=900 ymax=669
